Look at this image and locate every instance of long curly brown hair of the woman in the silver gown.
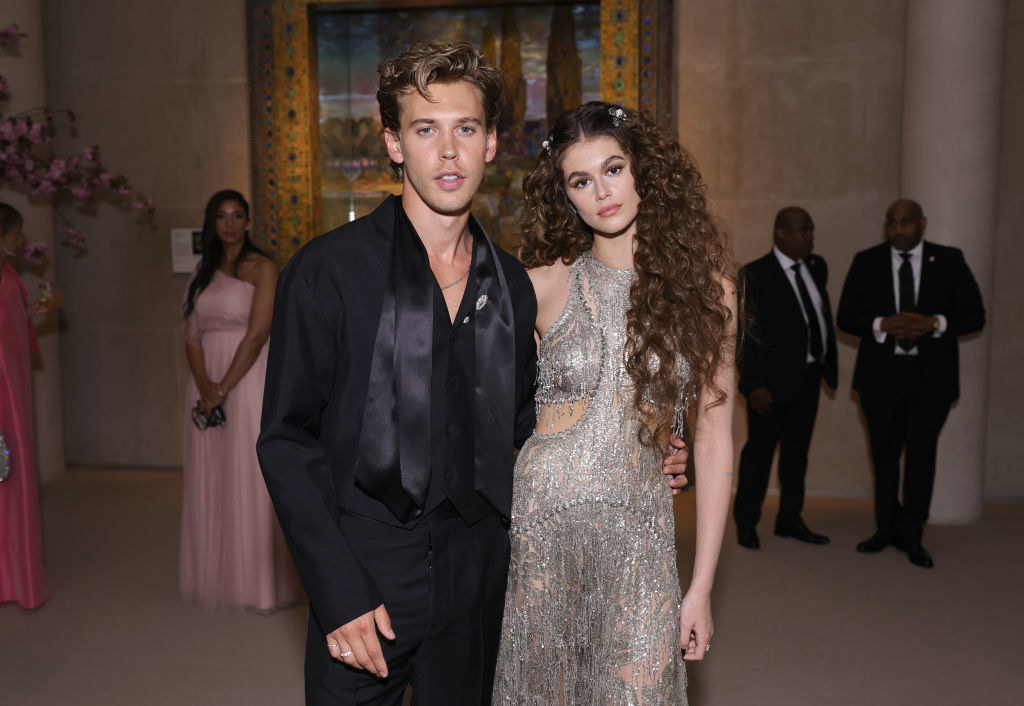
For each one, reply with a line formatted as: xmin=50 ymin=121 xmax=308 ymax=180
xmin=518 ymin=101 xmax=737 ymax=438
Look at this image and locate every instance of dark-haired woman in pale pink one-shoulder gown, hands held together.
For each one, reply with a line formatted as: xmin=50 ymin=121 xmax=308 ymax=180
xmin=180 ymin=190 xmax=300 ymax=612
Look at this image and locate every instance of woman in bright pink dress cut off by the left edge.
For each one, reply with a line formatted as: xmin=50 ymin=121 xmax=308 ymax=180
xmin=0 ymin=203 xmax=50 ymax=610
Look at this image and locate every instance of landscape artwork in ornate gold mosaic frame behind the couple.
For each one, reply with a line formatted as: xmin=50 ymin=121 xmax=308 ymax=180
xmin=241 ymin=0 xmax=672 ymax=263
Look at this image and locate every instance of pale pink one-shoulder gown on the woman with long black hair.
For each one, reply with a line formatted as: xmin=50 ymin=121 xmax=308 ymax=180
xmin=179 ymin=272 xmax=302 ymax=612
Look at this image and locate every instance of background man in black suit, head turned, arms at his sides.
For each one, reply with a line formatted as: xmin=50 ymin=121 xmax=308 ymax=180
xmin=732 ymin=206 xmax=837 ymax=549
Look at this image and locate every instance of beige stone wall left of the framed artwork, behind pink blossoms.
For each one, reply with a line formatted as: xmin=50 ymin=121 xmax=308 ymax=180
xmin=44 ymin=0 xmax=250 ymax=466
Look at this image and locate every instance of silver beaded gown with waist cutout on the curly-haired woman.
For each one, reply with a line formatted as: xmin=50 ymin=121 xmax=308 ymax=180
xmin=494 ymin=252 xmax=686 ymax=706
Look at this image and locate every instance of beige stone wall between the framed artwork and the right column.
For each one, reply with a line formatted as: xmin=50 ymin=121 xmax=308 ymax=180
xmin=676 ymin=0 xmax=903 ymax=495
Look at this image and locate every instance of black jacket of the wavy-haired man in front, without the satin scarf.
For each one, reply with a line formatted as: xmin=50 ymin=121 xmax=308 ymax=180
xmin=257 ymin=197 xmax=537 ymax=629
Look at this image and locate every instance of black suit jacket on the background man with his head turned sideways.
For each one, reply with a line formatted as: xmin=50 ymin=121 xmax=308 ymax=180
xmin=736 ymin=251 xmax=838 ymax=402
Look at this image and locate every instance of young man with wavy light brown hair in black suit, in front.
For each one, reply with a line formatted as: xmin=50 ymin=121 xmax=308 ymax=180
xmin=257 ymin=43 xmax=686 ymax=706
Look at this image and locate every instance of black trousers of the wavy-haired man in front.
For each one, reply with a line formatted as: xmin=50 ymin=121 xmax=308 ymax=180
xmin=305 ymin=504 xmax=509 ymax=706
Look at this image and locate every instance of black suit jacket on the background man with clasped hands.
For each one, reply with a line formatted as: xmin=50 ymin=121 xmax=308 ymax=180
xmin=837 ymin=242 xmax=985 ymax=403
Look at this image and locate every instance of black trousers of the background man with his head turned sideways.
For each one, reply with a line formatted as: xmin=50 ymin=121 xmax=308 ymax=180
xmin=732 ymin=365 xmax=821 ymax=530
